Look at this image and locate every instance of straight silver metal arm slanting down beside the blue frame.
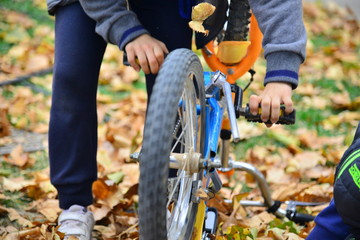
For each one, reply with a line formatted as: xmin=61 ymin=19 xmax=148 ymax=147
xmin=213 ymin=71 xmax=240 ymax=142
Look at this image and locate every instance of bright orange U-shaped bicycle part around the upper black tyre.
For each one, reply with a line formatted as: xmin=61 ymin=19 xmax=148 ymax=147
xmin=201 ymin=14 xmax=263 ymax=84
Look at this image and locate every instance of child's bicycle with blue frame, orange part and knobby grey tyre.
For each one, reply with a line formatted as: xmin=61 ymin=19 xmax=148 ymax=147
xmin=132 ymin=0 xmax=317 ymax=239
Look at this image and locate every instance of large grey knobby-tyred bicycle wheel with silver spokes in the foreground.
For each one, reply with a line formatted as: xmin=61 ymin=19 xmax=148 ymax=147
xmin=139 ymin=49 xmax=205 ymax=240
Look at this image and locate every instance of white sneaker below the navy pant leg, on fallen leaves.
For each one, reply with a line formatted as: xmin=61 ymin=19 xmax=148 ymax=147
xmin=58 ymin=205 xmax=94 ymax=240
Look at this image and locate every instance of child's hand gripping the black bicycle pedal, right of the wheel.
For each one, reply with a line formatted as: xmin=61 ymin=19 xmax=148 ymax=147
xmin=249 ymin=82 xmax=294 ymax=127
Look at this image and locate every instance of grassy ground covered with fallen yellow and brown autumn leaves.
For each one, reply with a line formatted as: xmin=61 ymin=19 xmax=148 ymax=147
xmin=0 ymin=0 xmax=360 ymax=239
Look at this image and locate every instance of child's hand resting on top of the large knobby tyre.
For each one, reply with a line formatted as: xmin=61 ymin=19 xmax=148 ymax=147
xmin=125 ymin=34 xmax=169 ymax=74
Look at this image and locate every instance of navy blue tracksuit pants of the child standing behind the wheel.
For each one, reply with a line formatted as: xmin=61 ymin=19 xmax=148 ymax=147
xmin=49 ymin=0 xmax=192 ymax=209
